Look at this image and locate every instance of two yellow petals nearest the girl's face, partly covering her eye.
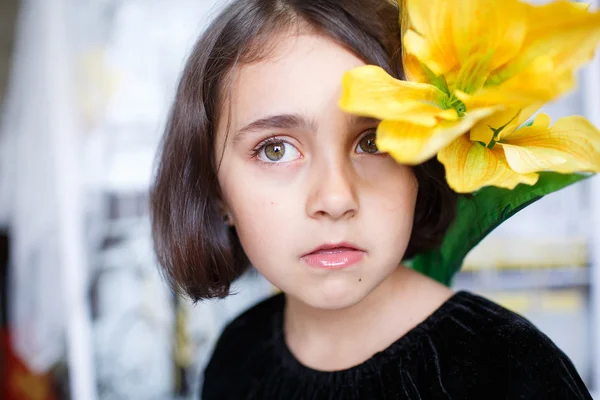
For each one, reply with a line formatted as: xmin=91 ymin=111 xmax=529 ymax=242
xmin=340 ymin=65 xmax=504 ymax=164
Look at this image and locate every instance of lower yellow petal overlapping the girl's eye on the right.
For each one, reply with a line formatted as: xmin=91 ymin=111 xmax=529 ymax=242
xmin=377 ymin=108 xmax=495 ymax=165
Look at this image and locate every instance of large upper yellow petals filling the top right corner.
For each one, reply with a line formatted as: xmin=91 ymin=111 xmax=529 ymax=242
xmin=403 ymin=0 xmax=600 ymax=105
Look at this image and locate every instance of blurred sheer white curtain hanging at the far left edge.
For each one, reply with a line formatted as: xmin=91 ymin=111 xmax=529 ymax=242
xmin=2 ymin=1 xmax=64 ymax=371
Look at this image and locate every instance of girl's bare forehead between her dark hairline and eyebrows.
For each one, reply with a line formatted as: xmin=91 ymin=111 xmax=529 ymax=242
xmin=229 ymin=34 xmax=364 ymax=129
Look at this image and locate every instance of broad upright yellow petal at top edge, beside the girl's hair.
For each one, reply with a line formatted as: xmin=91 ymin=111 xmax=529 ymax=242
xmin=404 ymin=0 xmax=526 ymax=75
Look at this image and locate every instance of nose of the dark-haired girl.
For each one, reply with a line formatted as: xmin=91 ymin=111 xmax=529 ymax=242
xmin=306 ymin=161 xmax=359 ymax=220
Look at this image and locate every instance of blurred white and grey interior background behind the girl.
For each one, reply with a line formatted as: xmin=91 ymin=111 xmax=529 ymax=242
xmin=0 ymin=0 xmax=600 ymax=400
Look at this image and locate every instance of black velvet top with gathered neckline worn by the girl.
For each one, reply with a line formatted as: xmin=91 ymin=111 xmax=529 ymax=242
xmin=202 ymin=292 xmax=592 ymax=400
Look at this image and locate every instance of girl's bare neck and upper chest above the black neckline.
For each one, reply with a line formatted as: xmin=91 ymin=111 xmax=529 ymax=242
xmin=284 ymin=267 xmax=438 ymax=370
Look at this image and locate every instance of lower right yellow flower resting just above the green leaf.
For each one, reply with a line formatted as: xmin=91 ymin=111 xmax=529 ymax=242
xmin=438 ymin=106 xmax=600 ymax=193
